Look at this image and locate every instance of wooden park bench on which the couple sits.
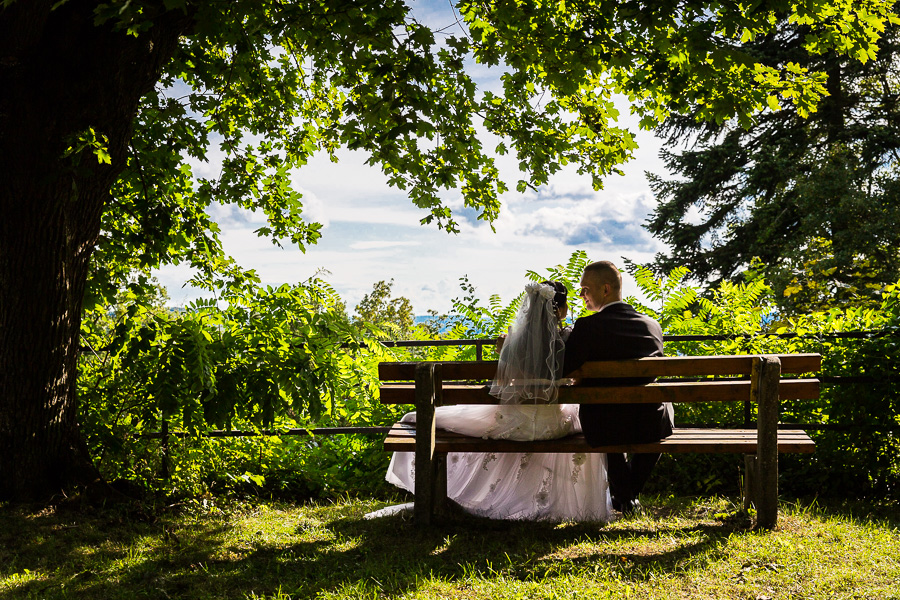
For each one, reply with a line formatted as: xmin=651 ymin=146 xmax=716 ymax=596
xmin=378 ymin=354 xmax=821 ymax=529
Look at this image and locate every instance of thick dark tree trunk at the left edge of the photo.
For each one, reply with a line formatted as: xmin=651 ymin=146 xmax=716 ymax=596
xmin=0 ymin=0 xmax=190 ymax=501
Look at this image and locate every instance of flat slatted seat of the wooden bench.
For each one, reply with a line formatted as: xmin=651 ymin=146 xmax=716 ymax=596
xmin=384 ymin=423 xmax=815 ymax=454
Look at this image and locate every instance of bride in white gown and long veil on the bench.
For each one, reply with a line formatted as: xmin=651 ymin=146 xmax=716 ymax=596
xmin=386 ymin=281 xmax=612 ymax=521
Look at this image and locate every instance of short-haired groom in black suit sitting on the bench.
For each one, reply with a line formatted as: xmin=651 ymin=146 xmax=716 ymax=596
xmin=563 ymin=261 xmax=672 ymax=514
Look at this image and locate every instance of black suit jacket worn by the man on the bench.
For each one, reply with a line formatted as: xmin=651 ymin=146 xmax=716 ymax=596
xmin=563 ymin=304 xmax=672 ymax=446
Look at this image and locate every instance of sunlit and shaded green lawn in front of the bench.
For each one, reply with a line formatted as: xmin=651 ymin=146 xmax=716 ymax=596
xmin=0 ymin=498 xmax=900 ymax=600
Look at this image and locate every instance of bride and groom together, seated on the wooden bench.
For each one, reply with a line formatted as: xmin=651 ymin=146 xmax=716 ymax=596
xmin=386 ymin=261 xmax=673 ymax=521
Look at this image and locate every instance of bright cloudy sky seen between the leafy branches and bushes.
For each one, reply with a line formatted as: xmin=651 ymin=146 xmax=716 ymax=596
xmin=155 ymin=0 xmax=665 ymax=315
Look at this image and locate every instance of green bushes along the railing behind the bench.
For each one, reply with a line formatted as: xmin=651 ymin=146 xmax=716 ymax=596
xmin=79 ymin=252 xmax=900 ymax=498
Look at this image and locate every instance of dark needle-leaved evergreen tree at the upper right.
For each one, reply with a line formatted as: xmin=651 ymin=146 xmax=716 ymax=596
xmin=646 ymin=11 xmax=900 ymax=308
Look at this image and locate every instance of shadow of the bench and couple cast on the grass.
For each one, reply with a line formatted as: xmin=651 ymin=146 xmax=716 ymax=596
xmin=331 ymin=502 xmax=736 ymax=592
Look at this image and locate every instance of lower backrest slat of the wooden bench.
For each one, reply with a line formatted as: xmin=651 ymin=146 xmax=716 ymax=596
xmin=381 ymin=379 xmax=819 ymax=405
